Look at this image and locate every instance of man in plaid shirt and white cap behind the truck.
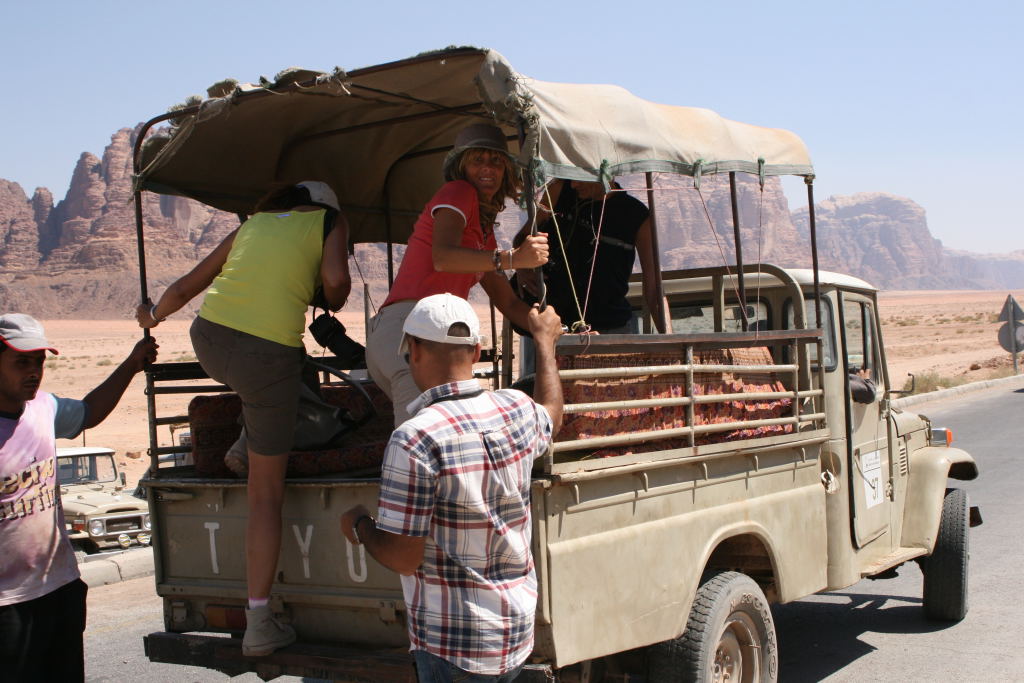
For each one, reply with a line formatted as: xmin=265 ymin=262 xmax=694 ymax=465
xmin=341 ymin=294 xmax=562 ymax=682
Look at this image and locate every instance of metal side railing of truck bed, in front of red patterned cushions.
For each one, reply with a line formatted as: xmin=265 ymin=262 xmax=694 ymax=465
xmin=544 ymin=330 xmax=825 ymax=474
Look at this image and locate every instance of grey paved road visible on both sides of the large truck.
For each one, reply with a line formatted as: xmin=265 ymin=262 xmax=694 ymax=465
xmin=86 ymin=387 xmax=1024 ymax=683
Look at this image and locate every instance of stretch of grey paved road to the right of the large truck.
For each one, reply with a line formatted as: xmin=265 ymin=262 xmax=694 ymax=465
xmin=773 ymin=387 xmax=1024 ymax=683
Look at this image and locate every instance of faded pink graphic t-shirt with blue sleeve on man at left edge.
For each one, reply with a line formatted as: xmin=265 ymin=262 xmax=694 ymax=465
xmin=0 ymin=391 xmax=85 ymax=605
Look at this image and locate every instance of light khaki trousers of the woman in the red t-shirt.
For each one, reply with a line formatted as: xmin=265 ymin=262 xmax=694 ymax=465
xmin=367 ymin=301 xmax=422 ymax=427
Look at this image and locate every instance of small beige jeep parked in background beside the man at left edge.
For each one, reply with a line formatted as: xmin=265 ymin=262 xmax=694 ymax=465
xmin=57 ymin=446 xmax=151 ymax=553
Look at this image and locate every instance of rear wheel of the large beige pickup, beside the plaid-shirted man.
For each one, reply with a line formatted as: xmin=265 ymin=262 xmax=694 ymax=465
xmin=647 ymin=571 xmax=778 ymax=683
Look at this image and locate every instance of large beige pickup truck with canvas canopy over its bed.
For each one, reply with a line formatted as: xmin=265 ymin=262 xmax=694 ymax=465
xmin=135 ymin=48 xmax=980 ymax=682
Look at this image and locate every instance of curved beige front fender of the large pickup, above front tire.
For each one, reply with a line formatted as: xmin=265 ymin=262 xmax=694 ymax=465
xmin=900 ymin=446 xmax=978 ymax=552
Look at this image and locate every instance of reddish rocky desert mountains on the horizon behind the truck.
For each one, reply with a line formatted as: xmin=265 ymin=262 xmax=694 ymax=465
xmin=0 ymin=128 xmax=1024 ymax=318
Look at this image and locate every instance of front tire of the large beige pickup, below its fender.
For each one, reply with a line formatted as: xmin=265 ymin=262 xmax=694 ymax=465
xmin=921 ymin=488 xmax=971 ymax=622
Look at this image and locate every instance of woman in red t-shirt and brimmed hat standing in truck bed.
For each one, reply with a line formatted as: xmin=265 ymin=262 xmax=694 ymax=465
xmin=367 ymin=124 xmax=548 ymax=426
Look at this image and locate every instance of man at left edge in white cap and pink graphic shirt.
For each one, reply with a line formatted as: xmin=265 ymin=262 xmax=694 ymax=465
xmin=0 ymin=313 xmax=157 ymax=682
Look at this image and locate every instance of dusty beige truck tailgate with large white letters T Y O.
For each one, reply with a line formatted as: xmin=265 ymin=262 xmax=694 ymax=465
xmin=145 ymin=478 xmax=408 ymax=647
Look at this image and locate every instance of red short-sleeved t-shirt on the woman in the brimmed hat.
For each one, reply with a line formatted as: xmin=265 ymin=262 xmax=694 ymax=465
xmin=384 ymin=180 xmax=498 ymax=306
